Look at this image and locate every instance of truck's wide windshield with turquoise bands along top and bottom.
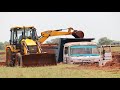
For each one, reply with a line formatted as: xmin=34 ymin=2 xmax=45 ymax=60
xmin=70 ymin=45 xmax=99 ymax=56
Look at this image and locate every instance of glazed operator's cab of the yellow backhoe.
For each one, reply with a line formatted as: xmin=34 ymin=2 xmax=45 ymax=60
xmin=10 ymin=27 xmax=37 ymax=49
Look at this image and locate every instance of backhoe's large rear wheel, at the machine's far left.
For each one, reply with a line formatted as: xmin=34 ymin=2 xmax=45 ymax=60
xmin=6 ymin=48 xmax=15 ymax=67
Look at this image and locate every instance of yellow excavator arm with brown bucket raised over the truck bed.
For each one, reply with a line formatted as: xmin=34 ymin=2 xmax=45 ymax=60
xmin=38 ymin=27 xmax=84 ymax=43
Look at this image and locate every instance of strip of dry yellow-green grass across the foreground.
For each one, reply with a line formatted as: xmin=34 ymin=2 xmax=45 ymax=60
xmin=0 ymin=64 xmax=120 ymax=78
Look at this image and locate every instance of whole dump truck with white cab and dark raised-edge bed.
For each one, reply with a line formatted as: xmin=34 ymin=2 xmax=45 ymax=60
xmin=56 ymin=38 xmax=101 ymax=64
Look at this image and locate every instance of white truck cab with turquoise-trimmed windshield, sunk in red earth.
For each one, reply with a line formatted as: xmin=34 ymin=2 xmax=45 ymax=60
xmin=63 ymin=42 xmax=101 ymax=64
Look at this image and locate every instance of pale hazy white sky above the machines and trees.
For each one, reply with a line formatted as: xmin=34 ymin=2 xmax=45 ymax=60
xmin=0 ymin=12 xmax=120 ymax=42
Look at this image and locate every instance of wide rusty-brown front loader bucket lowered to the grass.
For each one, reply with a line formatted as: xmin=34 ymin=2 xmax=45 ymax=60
xmin=22 ymin=53 xmax=57 ymax=66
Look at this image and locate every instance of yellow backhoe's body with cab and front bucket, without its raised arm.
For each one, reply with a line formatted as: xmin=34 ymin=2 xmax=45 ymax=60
xmin=6 ymin=26 xmax=56 ymax=66
